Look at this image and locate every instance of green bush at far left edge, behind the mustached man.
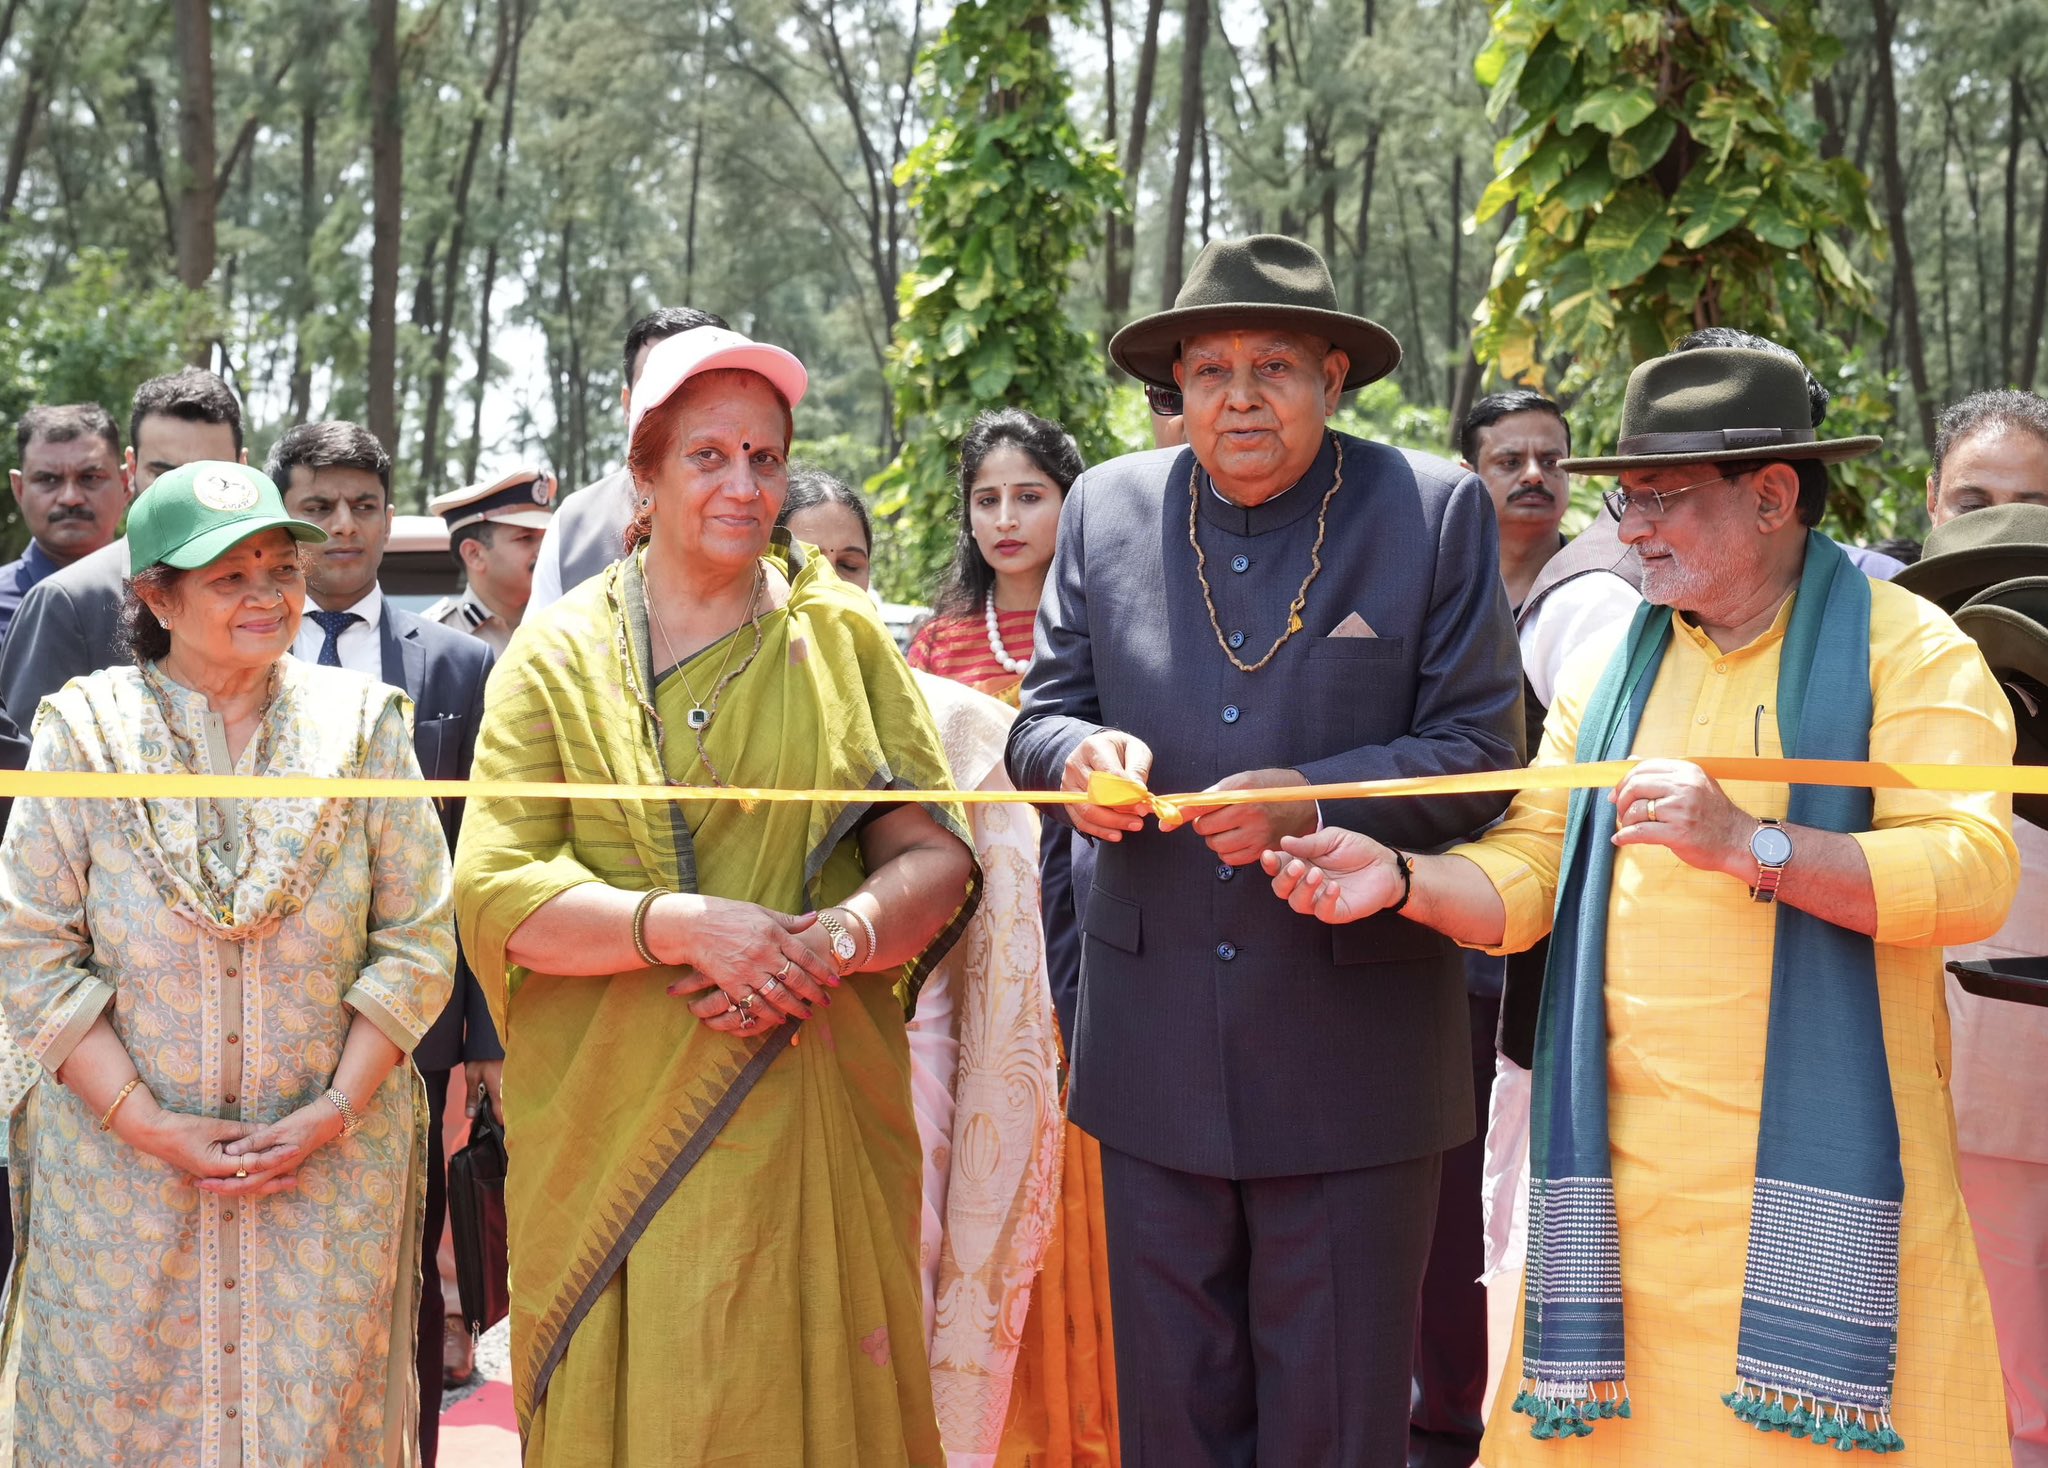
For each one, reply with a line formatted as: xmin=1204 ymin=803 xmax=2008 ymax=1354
xmin=0 ymin=250 xmax=217 ymax=561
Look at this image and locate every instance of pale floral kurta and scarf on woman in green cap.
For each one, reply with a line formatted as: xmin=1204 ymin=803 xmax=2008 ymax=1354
xmin=0 ymin=659 xmax=455 ymax=1468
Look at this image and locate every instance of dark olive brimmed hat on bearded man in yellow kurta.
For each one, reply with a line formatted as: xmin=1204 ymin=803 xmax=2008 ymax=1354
xmin=1559 ymin=346 xmax=1884 ymax=475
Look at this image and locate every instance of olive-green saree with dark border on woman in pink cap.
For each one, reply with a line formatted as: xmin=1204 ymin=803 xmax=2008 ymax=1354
xmin=457 ymin=534 xmax=975 ymax=1466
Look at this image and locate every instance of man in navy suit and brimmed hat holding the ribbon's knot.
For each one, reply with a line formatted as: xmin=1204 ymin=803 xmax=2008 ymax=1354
xmin=1010 ymin=235 xmax=1522 ymax=1468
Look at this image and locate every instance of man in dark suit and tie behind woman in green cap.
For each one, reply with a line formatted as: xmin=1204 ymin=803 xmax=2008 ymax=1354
xmin=264 ymin=422 xmax=506 ymax=1464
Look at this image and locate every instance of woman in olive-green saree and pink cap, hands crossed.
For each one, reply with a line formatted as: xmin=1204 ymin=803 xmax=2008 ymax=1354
xmin=457 ymin=328 xmax=977 ymax=1468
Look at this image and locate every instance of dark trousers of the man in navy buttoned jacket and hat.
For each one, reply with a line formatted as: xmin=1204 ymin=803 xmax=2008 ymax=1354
xmin=1102 ymin=1147 xmax=1442 ymax=1468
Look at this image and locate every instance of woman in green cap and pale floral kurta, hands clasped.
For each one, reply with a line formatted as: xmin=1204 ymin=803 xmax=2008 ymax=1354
xmin=0 ymin=463 xmax=455 ymax=1468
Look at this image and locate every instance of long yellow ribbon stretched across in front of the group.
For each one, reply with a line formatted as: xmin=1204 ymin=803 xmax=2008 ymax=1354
xmin=0 ymin=755 xmax=2048 ymax=806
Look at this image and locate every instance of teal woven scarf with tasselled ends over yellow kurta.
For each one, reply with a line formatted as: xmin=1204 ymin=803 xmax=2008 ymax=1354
xmin=1516 ymin=534 xmax=1905 ymax=1452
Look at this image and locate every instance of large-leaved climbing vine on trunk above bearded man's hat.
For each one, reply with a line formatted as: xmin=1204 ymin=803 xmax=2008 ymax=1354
xmin=1473 ymin=0 xmax=1880 ymax=393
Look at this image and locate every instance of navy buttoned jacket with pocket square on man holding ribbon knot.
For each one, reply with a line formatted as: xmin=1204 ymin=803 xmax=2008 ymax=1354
xmin=1008 ymin=434 xmax=1522 ymax=1177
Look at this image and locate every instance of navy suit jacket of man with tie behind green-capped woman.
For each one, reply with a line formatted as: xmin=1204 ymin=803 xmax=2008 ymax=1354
xmin=379 ymin=600 xmax=504 ymax=1071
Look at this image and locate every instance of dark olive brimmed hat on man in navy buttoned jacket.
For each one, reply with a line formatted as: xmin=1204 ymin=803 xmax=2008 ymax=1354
xmin=1110 ymin=235 xmax=1401 ymax=391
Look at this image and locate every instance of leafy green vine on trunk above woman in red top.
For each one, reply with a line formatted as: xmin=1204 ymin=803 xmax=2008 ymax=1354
xmin=870 ymin=0 xmax=1120 ymax=596
